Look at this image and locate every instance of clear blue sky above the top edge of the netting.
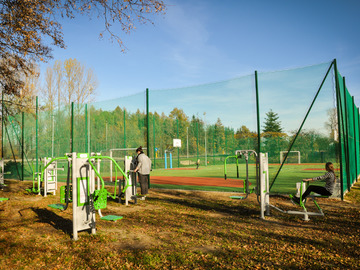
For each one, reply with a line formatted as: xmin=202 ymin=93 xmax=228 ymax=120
xmin=41 ymin=0 xmax=360 ymax=106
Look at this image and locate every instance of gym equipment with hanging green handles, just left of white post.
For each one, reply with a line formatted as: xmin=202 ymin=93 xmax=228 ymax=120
xmin=224 ymin=150 xmax=258 ymax=200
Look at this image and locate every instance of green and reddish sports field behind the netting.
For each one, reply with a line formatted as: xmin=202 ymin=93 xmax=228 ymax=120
xmin=151 ymin=163 xmax=325 ymax=193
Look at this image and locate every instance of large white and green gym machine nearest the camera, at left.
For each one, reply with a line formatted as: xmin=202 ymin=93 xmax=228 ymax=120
xmin=47 ymin=152 xmax=129 ymax=240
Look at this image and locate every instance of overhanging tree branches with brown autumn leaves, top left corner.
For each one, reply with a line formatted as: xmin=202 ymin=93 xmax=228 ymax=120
xmin=0 ymin=0 xmax=165 ymax=95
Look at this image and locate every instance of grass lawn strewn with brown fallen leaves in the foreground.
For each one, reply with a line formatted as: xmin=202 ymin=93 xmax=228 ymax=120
xmin=0 ymin=180 xmax=360 ymax=269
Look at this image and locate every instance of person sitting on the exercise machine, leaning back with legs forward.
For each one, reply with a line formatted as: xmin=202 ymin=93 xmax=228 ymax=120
xmin=290 ymin=162 xmax=336 ymax=205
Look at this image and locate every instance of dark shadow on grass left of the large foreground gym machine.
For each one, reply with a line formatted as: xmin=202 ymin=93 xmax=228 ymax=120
xmin=31 ymin=207 xmax=72 ymax=237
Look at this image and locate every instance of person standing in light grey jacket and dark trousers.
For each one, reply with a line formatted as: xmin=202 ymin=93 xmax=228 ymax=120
xmin=134 ymin=146 xmax=151 ymax=199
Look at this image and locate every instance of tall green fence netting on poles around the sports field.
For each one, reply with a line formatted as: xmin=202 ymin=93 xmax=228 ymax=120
xmin=2 ymin=60 xmax=360 ymax=198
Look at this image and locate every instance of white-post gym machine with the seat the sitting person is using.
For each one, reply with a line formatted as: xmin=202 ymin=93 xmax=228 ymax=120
xmin=260 ymin=153 xmax=328 ymax=221
